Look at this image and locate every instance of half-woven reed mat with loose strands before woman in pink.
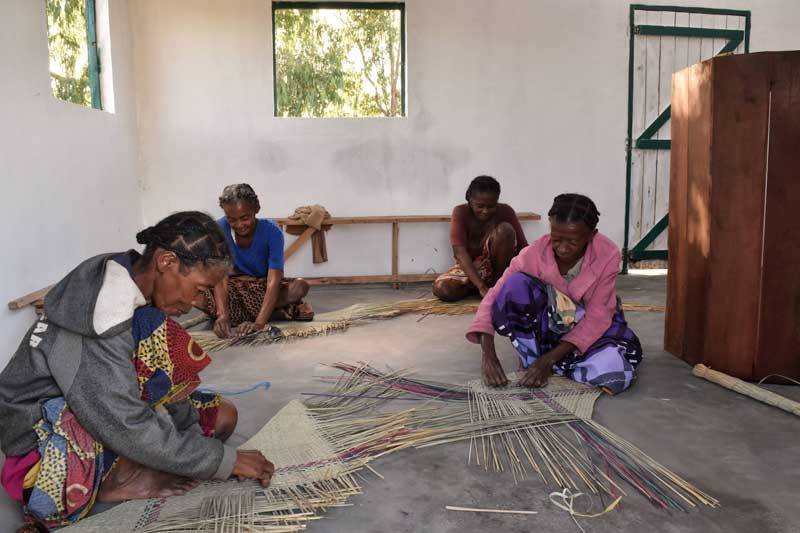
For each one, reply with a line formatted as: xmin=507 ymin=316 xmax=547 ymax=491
xmin=312 ymin=363 xmax=719 ymax=511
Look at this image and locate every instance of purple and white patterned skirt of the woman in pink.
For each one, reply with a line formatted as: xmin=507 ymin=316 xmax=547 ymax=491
xmin=492 ymin=272 xmax=642 ymax=394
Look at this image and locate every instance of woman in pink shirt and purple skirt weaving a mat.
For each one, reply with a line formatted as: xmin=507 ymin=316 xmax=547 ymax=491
xmin=467 ymin=194 xmax=642 ymax=393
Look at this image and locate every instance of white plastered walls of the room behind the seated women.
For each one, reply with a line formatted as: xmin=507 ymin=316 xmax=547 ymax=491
xmin=0 ymin=0 xmax=800 ymax=366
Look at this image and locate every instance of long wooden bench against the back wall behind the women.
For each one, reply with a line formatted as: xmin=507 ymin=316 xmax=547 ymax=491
xmin=274 ymin=212 xmax=542 ymax=289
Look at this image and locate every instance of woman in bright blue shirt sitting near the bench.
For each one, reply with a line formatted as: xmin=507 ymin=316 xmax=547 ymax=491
xmin=200 ymin=183 xmax=314 ymax=338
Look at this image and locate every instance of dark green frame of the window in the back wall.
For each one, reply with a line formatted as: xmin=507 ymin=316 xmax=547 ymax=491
xmin=270 ymin=0 xmax=406 ymax=119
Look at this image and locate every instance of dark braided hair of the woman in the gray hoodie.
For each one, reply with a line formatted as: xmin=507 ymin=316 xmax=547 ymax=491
xmin=136 ymin=211 xmax=231 ymax=267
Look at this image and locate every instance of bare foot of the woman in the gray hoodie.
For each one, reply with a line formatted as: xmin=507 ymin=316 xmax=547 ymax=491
xmin=97 ymin=457 xmax=198 ymax=502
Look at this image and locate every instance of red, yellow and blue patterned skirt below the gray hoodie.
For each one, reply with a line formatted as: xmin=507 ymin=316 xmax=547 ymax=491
xmin=0 ymin=307 xmax=220 ymax=528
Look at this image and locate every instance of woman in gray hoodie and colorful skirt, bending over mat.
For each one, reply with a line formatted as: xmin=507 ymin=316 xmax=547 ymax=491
xmin=0 ymin=212 xmax=274 ymax=527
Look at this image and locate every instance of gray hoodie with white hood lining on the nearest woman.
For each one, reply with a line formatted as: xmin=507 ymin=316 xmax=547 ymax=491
xmin=0 ymin=254 xmax=236 ymax=479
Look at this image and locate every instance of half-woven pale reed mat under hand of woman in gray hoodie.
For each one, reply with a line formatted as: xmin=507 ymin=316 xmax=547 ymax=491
xmin=64 ymin=400 xmax=363 ymax=533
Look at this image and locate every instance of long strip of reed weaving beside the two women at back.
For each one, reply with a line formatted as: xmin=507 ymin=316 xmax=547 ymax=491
xmin=192 ymin=298 xmax=664 ymax=352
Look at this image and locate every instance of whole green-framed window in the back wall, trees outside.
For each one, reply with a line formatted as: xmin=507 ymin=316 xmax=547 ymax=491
xmin=272 ymin=2 xmax=405 ymax=117
